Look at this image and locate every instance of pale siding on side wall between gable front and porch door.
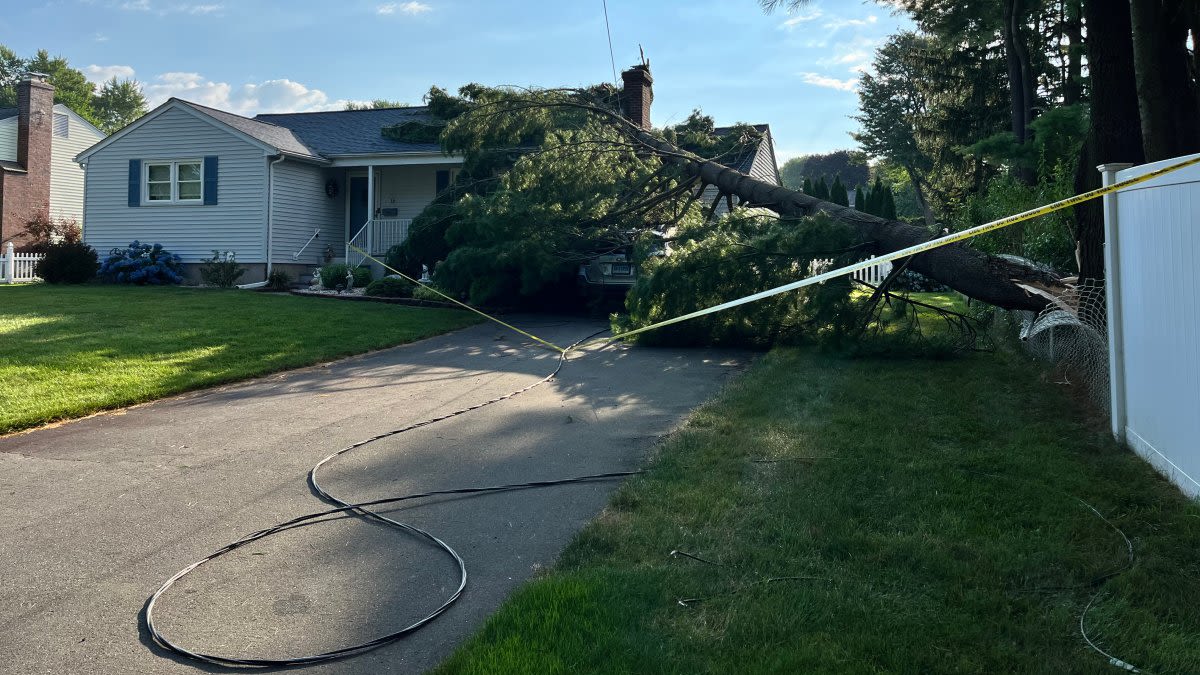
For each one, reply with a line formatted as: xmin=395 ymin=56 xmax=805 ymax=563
xmin=271 ymin=161 xmax=346 ymax=265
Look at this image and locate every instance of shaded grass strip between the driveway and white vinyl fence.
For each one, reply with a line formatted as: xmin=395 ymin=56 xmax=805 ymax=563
xmin=437 ymin=333 xmax=1200 ymax=675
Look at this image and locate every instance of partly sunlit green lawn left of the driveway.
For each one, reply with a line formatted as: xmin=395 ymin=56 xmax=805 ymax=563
xmin=0 ymin=283 xmax=478 ymax=432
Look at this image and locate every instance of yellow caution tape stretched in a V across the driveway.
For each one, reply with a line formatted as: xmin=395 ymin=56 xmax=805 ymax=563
xmin=349 ymin=155 xmax=1200 ymax=353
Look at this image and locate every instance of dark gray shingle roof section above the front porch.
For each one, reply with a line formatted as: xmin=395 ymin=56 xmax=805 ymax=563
xmin=254 ymin=106 xmax=442 ymax=156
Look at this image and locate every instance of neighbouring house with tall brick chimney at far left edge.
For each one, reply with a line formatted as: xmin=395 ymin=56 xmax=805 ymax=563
xmin=0 ymin=73 xmax=104 ymax=245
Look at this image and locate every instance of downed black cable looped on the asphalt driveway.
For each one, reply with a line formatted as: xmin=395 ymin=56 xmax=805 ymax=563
xmin=144 ymin=330 xmax=624 ymax=668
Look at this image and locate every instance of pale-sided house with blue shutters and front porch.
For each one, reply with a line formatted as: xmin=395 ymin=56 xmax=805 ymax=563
xmin=77 ymin=98 xmax=462 ymax=282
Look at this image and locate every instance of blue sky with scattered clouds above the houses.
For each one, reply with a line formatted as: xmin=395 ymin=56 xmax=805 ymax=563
xmin=0 ymin=0 xmax=911 ymax=163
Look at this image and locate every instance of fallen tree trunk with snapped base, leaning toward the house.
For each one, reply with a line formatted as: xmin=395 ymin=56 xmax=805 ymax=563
xmin=630 ymin=129 xmax=1066 ymax=311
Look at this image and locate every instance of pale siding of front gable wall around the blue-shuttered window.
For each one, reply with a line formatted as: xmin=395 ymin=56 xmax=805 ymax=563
xmin=84 ymin=108 xmax=266 ymax=263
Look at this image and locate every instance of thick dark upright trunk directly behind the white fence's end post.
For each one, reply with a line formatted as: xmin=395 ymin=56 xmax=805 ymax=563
xmin=1075 ymin=0 xmax=1145 ymax=279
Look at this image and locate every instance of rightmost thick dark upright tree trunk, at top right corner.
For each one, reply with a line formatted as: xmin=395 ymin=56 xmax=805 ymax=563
xmin=1130 ymin=0 xmax=1200 ymax=162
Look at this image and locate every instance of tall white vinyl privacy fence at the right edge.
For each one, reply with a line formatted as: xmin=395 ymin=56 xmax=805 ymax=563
xmin=1100 ymin=155 xmax=1200 ymax=496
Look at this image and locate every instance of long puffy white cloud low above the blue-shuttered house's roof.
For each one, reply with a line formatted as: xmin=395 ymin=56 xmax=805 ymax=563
xmin=144 ymin=72 xmax=346 ymax=117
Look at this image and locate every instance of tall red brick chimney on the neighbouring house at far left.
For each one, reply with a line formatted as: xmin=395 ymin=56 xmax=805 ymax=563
xmin=0 ymin=72 xmax=54 ymax=245
